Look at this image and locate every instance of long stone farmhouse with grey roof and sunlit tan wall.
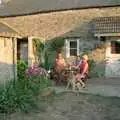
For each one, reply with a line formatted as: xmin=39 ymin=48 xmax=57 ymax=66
xmin=0 ymin=0 xmax=120 ymax=79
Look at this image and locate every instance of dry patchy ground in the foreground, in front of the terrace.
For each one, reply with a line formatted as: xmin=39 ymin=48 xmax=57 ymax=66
xmin=0 ymin=93 xmax=120 ymax=120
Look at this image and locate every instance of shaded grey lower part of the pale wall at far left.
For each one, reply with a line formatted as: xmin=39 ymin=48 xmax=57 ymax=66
xmin=0 ymin=62 xmax=14 ymax=83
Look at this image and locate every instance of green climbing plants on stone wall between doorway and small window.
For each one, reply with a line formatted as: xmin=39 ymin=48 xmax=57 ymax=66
xmin=33 ymin=38 xmax=64 ymax=69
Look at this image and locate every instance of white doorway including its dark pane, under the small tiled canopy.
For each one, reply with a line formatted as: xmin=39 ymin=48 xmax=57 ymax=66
xmin=106 ymin=39 xmax=120 ymax=77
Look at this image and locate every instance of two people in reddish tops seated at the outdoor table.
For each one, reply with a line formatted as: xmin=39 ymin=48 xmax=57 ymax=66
xmin=51 ymin=53 xmax=88 ymax=87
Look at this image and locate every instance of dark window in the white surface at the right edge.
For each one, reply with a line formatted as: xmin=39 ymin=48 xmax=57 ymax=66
xmin=111 ymin=40 xmax=120 ymax=54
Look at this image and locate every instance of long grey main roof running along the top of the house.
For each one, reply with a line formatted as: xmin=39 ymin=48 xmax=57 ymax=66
xmin=0 ymin=0 xmax=120 ymax=16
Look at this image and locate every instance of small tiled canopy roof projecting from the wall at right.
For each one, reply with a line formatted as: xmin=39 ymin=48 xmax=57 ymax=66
xmin=93 ymin=16 xmax=120 ymax=34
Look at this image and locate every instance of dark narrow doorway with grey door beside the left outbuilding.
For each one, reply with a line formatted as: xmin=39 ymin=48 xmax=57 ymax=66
xmin=17 ymin=38 xmax=28 ymax=61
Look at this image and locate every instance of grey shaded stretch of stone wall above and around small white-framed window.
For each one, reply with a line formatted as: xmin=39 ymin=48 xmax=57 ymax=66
xmin=47 ymin=21 xmax=100 ymax=52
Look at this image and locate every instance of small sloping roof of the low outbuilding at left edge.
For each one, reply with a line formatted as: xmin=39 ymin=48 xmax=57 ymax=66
xmin=0 ymin=22 xmax=20 ymax=37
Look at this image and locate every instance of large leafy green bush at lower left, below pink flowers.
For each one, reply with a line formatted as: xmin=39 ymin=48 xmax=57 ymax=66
xmin=0 ymin=76 xmax=51 ymax=113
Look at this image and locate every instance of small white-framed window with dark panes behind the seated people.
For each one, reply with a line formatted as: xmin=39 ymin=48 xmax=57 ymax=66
xmin=66 ymin=39 xmax=79 ymax=57
